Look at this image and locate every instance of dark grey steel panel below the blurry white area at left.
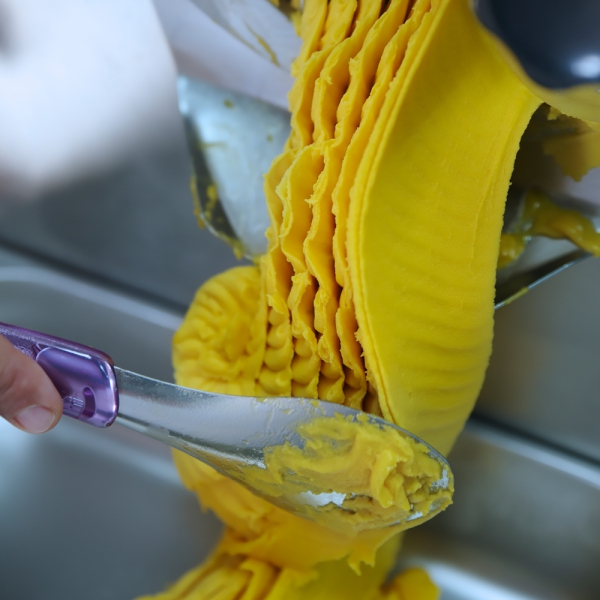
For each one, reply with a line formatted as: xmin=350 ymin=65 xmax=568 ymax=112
xmin=0 ymin=134 xmax=240 ymax=310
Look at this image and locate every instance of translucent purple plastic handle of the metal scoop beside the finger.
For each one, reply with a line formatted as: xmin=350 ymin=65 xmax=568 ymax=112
xmin=0 ymin=323 xmax=119 ymax=427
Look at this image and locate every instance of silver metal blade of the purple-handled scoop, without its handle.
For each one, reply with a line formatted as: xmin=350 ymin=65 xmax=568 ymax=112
xmin=115 ymin=367 xmax=454 ymax=529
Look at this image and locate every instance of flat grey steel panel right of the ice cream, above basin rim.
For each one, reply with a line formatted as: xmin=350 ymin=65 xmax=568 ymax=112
xmin=477 ymin=259 xmax=600 ymax=461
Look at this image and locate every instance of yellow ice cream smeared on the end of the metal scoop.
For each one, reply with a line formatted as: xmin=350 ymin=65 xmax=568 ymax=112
xmin=242 ymin=414 xmax=453 ymax=532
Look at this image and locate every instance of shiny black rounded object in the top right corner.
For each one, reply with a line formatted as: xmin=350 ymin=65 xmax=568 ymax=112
xmin=474 ymin=0 xmax=600 ymax=89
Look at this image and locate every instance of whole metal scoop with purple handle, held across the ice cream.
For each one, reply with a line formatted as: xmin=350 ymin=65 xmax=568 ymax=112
xmin=0 ymin=324 xmax=454 ymax=531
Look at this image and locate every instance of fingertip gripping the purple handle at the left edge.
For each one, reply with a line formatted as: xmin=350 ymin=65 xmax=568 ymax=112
xmin=0 ymin=335 xmax=63 ymax=433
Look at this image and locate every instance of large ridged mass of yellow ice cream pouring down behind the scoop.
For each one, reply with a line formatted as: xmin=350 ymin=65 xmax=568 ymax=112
xmin=139 ymin=0 xmax=600 ymax=600
